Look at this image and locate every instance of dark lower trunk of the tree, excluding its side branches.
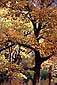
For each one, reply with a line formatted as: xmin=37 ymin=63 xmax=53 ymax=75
xmin=33 ymin=51 xmax=41 ymax=85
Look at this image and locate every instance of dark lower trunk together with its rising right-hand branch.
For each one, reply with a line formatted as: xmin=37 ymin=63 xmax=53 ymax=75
xmin=33 ymin=50 xmax=53 ymax=85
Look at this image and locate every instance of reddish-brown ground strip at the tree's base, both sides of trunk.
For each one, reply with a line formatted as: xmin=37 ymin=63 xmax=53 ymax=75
xmin=0 ymin=80 xmax=55 ymax=85
